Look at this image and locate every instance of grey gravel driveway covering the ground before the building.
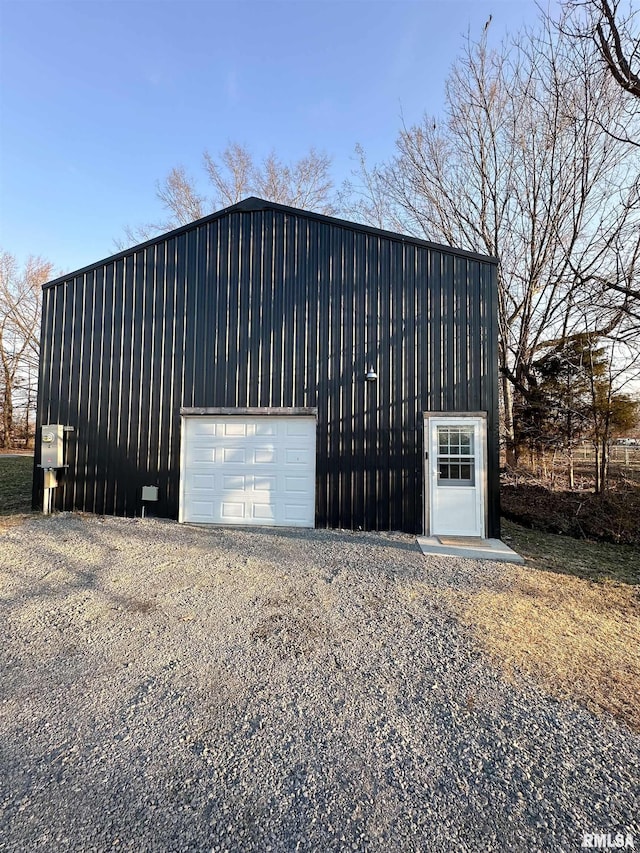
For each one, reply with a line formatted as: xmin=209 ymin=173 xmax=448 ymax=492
xmin=0 ymin=515 xmax=640 ymax=853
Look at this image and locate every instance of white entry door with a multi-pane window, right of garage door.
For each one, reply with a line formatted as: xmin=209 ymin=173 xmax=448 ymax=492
xmin=425 ymin=415 xmax=486 ymax=538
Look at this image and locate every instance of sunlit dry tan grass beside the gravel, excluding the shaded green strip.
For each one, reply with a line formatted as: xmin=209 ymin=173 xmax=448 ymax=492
xmin=450 ymin=566 xmax=640 ymax=731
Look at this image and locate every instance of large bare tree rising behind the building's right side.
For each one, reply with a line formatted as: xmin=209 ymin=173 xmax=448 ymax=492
xmin=350 ymin=22 xmax=640 ymax=461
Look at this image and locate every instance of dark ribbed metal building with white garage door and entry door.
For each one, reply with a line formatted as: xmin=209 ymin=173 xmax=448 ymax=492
xmin=34 ymin=198 xmax=499 ymax=536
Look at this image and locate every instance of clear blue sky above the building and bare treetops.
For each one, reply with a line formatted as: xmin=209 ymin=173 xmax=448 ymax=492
xmin=0 ymin=0 xmax=552 ymax=272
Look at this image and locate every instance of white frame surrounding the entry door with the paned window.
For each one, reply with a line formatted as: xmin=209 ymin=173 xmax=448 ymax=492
xmin=422 ymin=412 xmax=488 ymax=539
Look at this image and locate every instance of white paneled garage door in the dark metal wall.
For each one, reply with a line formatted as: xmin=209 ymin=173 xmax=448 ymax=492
xmin=180 ymin=415 xmax=316 ymax=527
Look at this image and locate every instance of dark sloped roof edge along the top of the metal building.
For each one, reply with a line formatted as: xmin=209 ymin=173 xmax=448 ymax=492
xmin=42 ymin=196 xmax=498 ymax=290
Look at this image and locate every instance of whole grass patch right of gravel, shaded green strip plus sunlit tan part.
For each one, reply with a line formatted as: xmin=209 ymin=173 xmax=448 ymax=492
xmin=440 ymin=522 xmax=640 ymax=731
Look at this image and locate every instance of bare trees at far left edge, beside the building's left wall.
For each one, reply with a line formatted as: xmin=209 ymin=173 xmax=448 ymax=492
xmin=0 ymin=252 xmax=53 ymax=447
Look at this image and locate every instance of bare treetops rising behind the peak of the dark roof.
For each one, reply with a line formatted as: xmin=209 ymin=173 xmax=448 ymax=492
xmin=122 ymin=142 xmax=335 ymax=248
